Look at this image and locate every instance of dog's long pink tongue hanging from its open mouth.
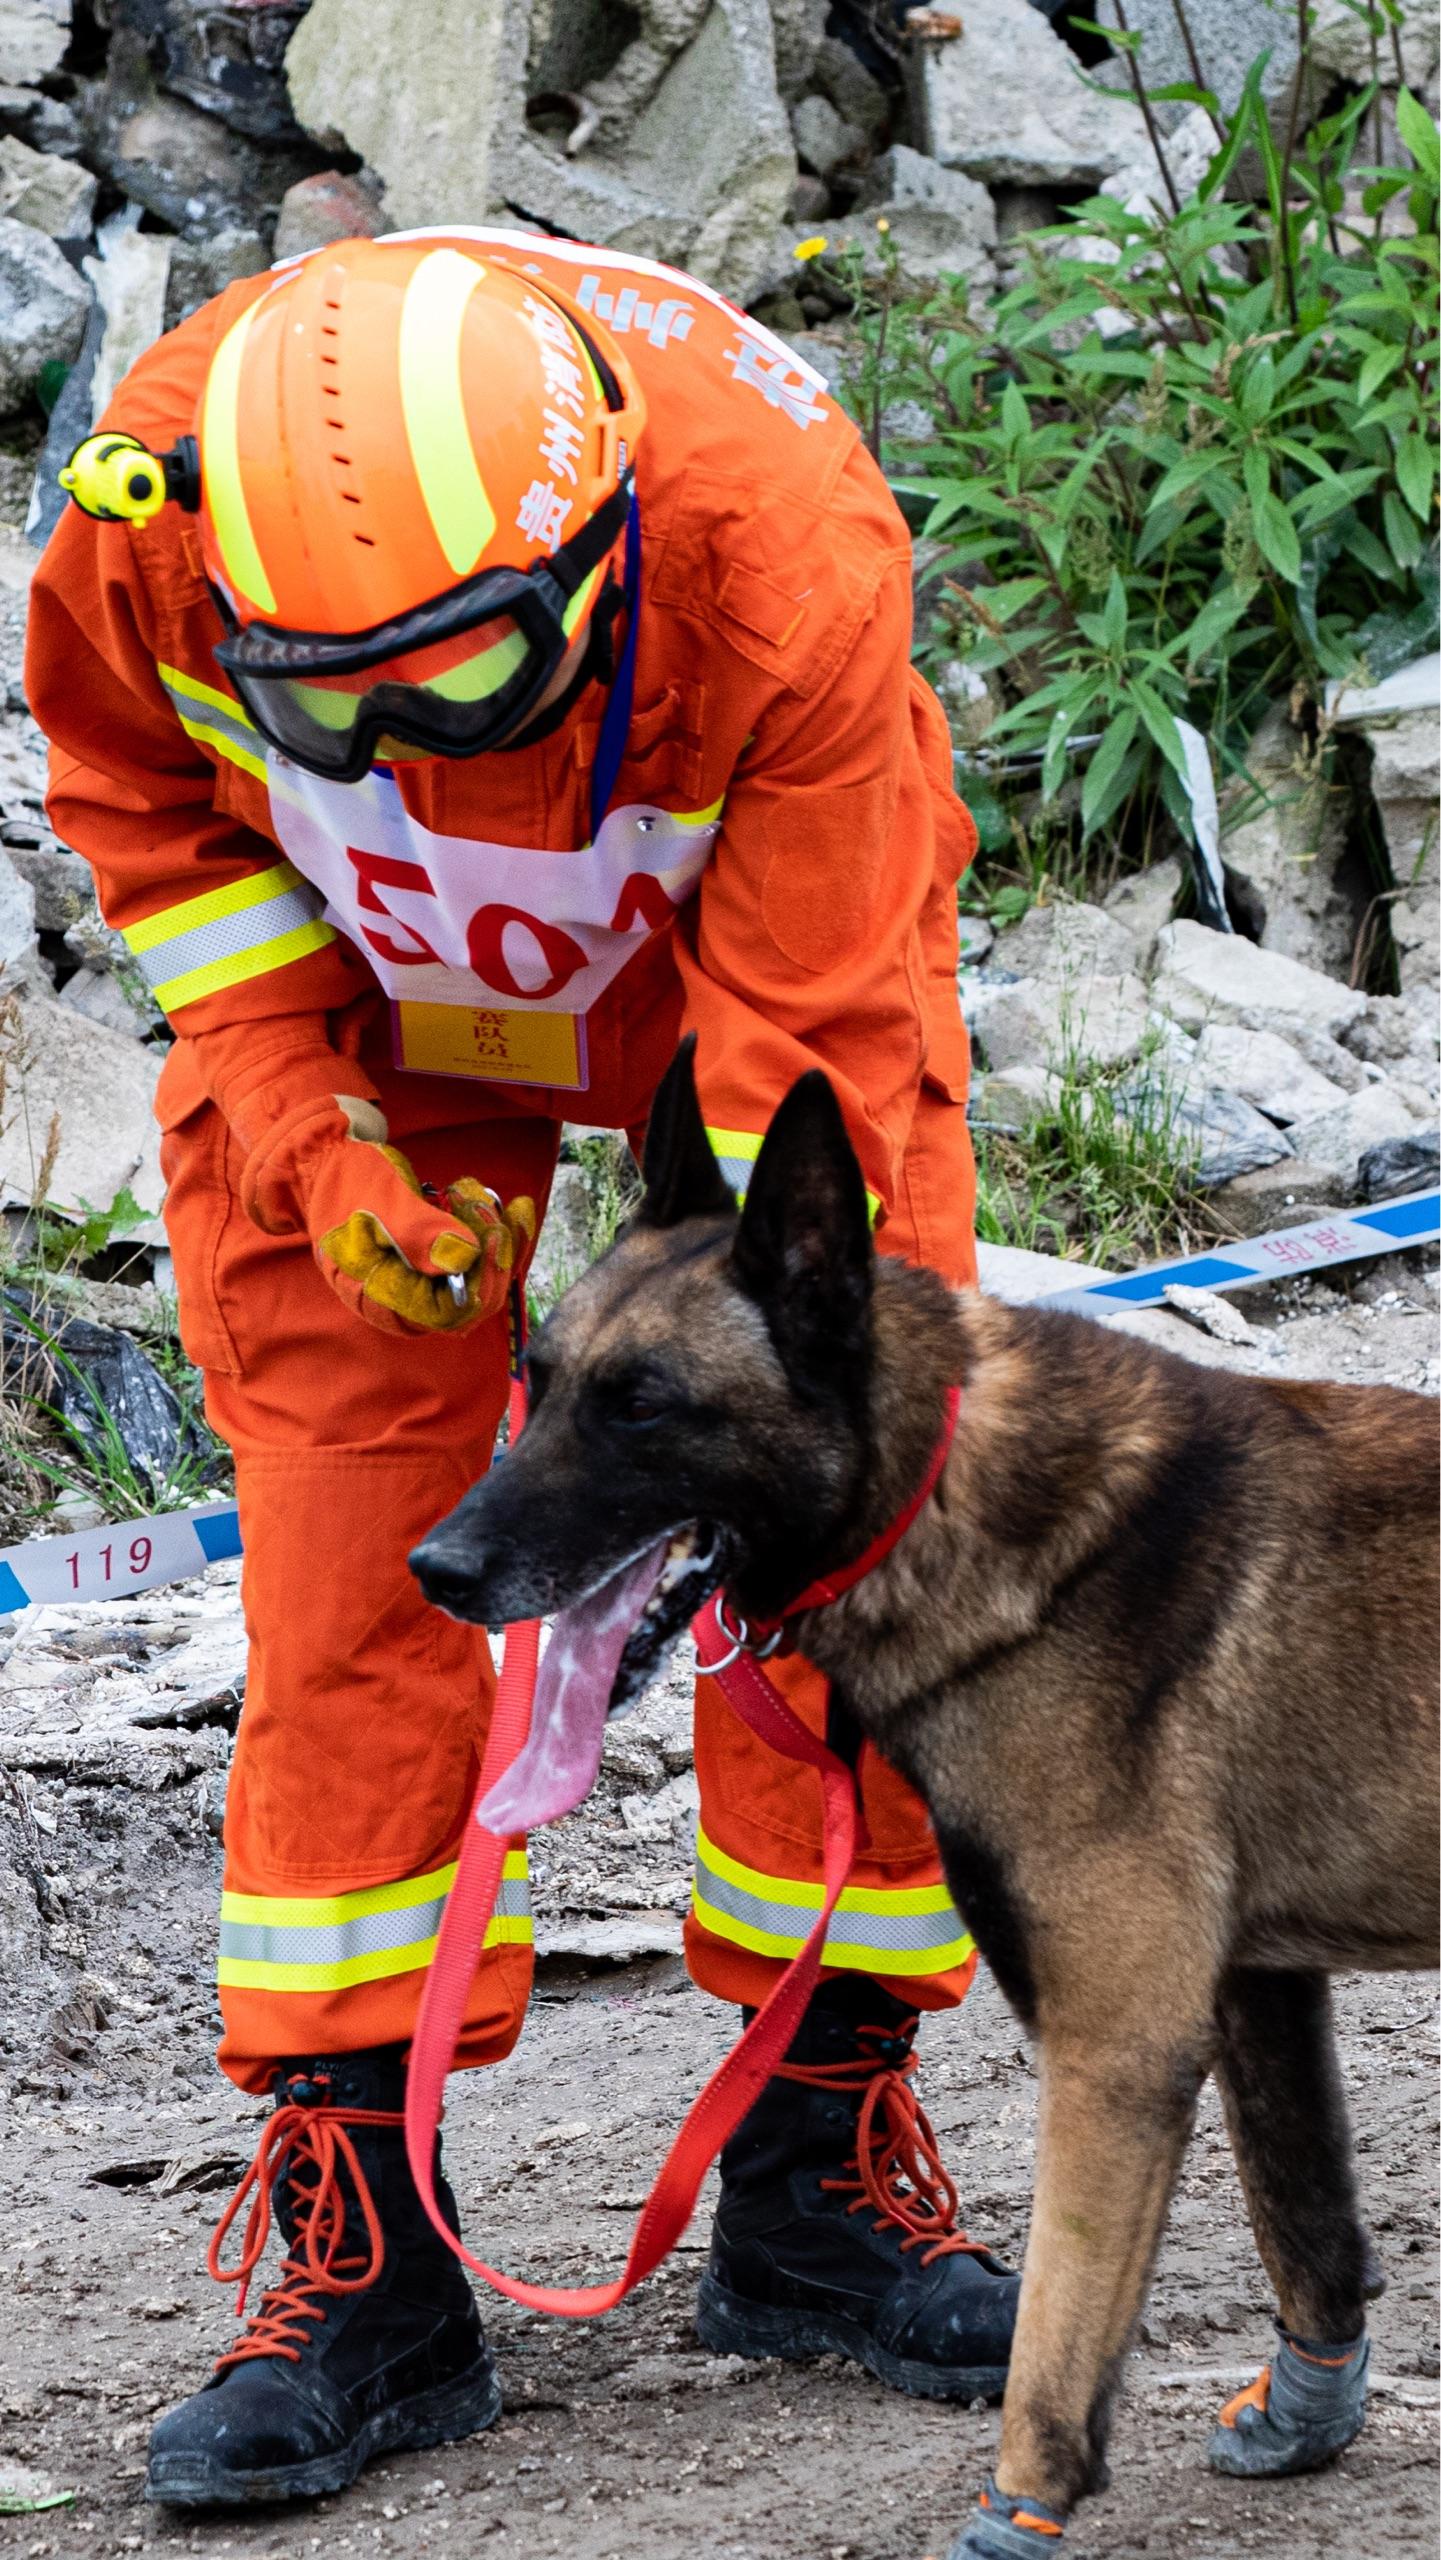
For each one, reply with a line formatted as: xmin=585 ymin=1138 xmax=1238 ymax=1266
xmin=476 ymin=1539 xmax=668 ymax=1833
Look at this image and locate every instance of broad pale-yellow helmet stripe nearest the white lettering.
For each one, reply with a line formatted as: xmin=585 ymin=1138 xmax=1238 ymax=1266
xmin=399 ymin=248 xmax=497 ymax=579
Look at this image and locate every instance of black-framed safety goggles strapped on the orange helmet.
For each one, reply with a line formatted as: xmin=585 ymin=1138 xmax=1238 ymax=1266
xmin=212 ymin=474 xmax=632 ymax=783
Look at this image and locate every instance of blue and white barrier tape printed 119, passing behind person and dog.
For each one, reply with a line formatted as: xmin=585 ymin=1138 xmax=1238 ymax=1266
xmin=0 ymin=1190 xmax=1441 ymax=1618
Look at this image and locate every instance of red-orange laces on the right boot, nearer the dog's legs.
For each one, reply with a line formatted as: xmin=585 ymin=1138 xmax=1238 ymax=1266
xmin=776 ymin=2017 xmax=985 ymax=2266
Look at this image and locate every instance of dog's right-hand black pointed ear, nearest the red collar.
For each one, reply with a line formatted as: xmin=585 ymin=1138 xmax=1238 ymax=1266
xmin=732 ymin=1068 xmax=875 ymax=1388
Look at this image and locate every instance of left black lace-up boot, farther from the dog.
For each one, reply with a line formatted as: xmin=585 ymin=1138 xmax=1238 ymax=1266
xmin=146 ymin=2045 xmax=499 ymax=2506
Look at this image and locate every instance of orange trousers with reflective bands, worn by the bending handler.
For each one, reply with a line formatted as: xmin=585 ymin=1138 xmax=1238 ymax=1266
xmin=164 ymin=1088 xmax=975 ymax=2092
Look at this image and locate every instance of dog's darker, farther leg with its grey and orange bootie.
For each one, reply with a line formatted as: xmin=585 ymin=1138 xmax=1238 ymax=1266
xmin=1211 ymin=1971 xmax=1382 ymax=2478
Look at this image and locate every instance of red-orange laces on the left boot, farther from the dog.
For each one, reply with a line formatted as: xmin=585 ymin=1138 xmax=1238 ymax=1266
xmin=205 ymin=2107 xmax=404 ymax=2373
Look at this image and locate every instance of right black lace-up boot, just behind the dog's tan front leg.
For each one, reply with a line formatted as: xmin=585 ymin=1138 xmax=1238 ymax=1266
xmin=696 ymin=1974 xmax=1021 ymax=2399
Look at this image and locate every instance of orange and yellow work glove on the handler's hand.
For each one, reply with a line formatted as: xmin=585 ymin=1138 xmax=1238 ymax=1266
xmin=241 ymin=1096 xmax=535 ymax=1334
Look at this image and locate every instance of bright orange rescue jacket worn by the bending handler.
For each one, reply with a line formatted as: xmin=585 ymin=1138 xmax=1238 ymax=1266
xmin=28 ymin=233 xmax=975 ymax=1206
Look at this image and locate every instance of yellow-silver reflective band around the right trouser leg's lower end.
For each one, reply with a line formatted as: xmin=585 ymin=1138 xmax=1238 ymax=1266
xmin=691 ymin=1830 xmax=975 ymax=1974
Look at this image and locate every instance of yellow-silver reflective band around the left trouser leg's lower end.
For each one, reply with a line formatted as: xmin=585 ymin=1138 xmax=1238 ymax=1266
xmin=218 ymin=1848 xmax=535 ymax=1992
